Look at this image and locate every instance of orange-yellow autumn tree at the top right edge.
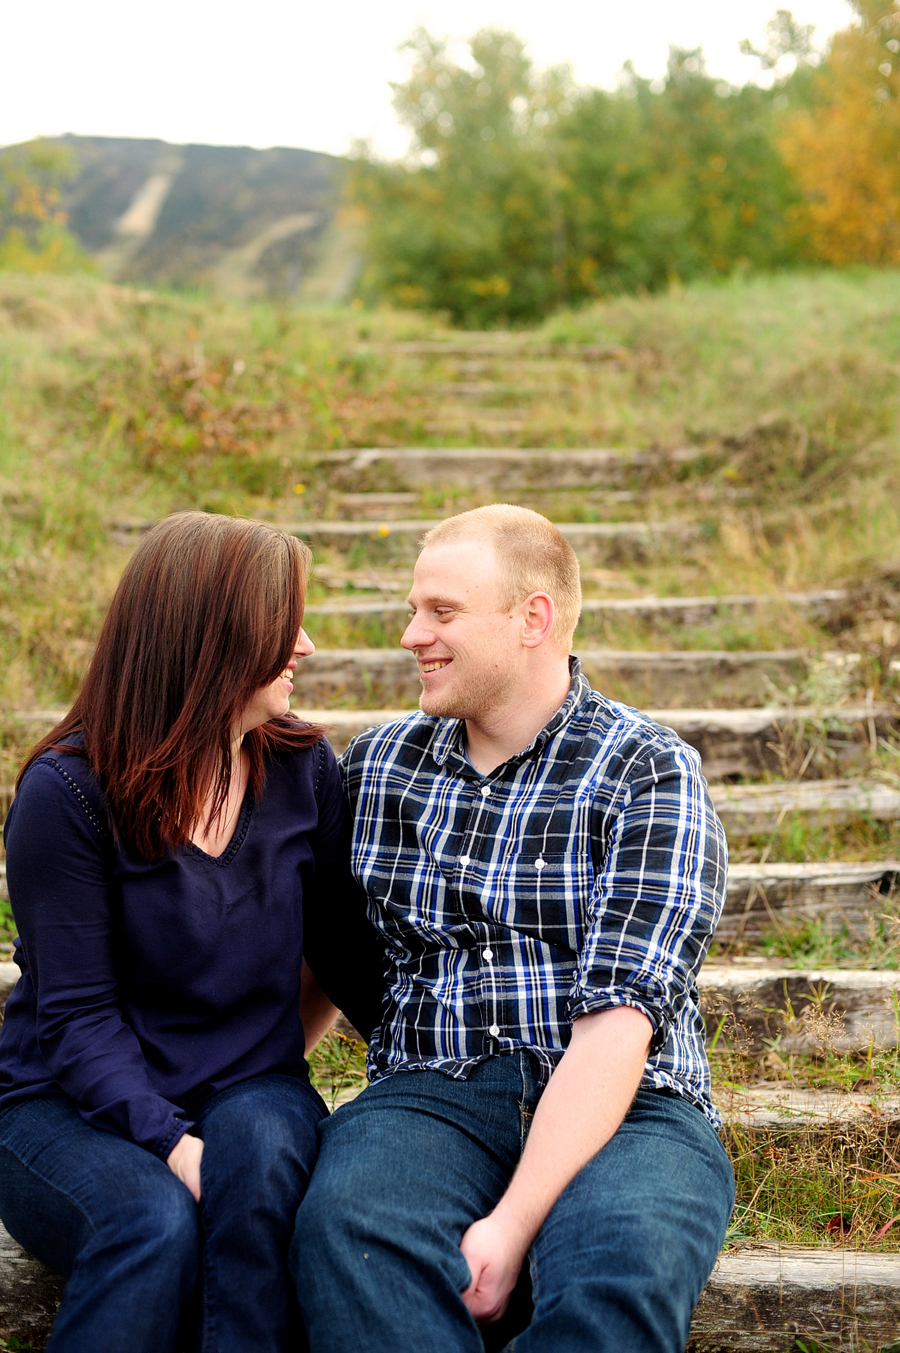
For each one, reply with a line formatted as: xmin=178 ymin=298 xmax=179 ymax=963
xmin=780 ymin=0 xmax=900 ymax=265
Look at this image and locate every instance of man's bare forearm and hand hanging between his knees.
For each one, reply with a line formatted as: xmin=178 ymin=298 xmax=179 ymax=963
xmin=460 ymin=1005 xmax=652 ymax=1321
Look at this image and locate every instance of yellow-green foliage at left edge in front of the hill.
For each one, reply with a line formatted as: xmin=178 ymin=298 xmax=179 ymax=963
xmin=0 ymin=141 xmax=91 ymax=272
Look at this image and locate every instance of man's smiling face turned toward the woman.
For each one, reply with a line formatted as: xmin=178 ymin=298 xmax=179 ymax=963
xmin=401 ymin=537 xmax=522 ymax=723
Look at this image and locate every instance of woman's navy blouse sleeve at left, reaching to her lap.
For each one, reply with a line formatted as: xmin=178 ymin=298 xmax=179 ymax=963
xmin=5 ymin=762 xmax=192 ymax=1160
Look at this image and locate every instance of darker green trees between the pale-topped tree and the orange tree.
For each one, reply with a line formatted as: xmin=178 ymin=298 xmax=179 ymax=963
xmin=558 ymin=50 xmax=797 ymax=299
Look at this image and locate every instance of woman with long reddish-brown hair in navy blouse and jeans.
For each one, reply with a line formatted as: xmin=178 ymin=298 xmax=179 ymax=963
xmin=0 ymin=513 xmax=382 ymax=1353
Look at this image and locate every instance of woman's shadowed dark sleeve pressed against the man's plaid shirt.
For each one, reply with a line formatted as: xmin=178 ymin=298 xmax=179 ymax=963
xmin=303 ymin=740 xmax=386 ymax=1040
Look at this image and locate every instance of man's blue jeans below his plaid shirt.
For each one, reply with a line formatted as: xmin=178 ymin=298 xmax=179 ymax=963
xmin=291 ymin=1053 xmax=734 ymax=1353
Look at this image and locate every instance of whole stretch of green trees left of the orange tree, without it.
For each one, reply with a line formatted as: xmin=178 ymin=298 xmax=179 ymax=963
xmin=349 ymin=26 xmax=803 ymax=325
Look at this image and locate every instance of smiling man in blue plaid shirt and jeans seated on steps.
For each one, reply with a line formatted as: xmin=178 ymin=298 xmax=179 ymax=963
xmin=292 ymin=505 xmax=734 ymax=1353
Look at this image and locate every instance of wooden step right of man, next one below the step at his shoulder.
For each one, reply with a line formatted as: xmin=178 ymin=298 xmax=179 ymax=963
xmin=711 ymin=779 xmax=900 ymax=836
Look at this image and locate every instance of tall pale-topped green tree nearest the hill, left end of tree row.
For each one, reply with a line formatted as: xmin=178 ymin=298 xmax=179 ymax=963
xmin=351 ymin=28 xmax=572 ymax=326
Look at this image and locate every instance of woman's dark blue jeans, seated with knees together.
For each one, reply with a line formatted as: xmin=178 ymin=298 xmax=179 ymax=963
xmin=0 ymin=1076 xmax=326 ymax=1353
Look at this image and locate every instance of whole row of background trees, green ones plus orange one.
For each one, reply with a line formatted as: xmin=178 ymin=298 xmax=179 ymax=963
xmin=348 ymin=0 xmax=900 ymax=326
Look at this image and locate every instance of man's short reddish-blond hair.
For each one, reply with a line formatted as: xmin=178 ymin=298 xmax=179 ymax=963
xmin=422 ymin=503 xmax=581 ymax=652
